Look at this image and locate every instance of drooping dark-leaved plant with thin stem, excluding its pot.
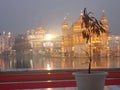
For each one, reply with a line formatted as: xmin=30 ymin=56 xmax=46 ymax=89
xmin=81 ymin=8 xmax=106 ymax=73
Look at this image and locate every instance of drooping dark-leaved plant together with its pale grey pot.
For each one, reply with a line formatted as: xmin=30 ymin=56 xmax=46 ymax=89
xmin=73 ymin=8 xmax=107 ymax=90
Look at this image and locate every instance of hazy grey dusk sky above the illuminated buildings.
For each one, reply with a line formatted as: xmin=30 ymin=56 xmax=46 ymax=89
xmin=0 ymin=0 xmax=120 ymax=34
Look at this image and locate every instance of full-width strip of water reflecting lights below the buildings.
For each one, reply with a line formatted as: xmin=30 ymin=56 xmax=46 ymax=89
xmin=0 ymin=54 xmax=120 ymax=71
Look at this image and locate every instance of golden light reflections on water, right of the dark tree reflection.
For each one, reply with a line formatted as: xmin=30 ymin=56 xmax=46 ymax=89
xmin=33 ymin=57 xmax=120 ymax=70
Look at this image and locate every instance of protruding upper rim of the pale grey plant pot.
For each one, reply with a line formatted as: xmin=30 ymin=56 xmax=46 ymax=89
xmin=72 ymin=71 xmax=108 ymax=76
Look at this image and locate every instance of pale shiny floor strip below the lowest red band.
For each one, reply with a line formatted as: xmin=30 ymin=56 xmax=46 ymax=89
xmin=17 ymin=85 xmax=120 ymax=90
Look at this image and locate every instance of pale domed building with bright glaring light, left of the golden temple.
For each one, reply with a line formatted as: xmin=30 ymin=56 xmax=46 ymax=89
xmin=27 ymin=26 xmax=63 ymax=56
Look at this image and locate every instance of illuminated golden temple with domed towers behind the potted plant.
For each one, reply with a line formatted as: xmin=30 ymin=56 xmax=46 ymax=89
xmin=62 ymin=12 xmax=109 ymax=57
